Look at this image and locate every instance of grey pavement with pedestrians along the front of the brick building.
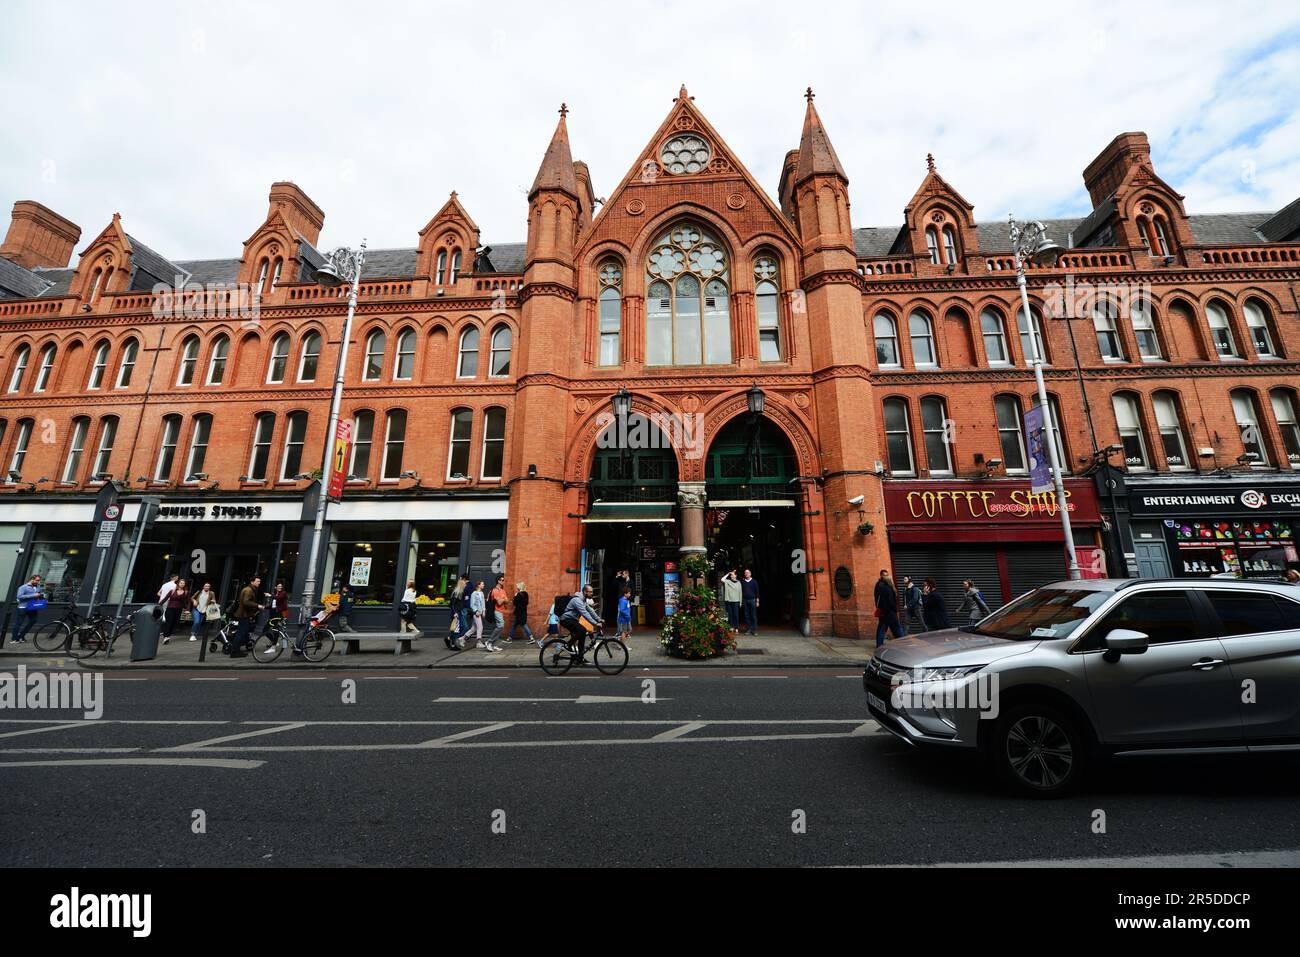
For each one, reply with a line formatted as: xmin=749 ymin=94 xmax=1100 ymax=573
xmin=0 ymin=628 xmax=875 ymax=671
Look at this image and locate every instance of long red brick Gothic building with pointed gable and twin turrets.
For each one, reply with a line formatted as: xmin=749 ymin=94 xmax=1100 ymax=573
xmin=0 ymin=90 xmax=1300 ymax=635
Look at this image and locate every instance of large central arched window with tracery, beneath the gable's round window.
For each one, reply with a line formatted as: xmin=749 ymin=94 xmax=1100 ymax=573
xmin=646 ymin=222 xmax=732 ymax=365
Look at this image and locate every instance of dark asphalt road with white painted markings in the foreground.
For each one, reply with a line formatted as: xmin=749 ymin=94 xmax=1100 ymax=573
xmin=0 ymin=670 xmax=1300 ymax=867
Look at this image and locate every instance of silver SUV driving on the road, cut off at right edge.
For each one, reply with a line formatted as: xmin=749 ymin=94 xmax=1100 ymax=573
xmin=862 ymin=579 xmax=1300 ymax=797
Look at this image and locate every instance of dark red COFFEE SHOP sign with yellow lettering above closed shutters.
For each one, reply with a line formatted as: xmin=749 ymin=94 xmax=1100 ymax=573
xmin=885 ymin=481 xmax=1100 ymax=523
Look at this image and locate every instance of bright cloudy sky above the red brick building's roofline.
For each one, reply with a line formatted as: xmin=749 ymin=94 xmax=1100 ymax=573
xmin=0 ymin=0 xmax=1300 ymax=259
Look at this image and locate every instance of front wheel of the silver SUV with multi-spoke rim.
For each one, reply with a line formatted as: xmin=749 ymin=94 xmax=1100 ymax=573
xmin=989 ymin=703 xmax=1088 ymax=798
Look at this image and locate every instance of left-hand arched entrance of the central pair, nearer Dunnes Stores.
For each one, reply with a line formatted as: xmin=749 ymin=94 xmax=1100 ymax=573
xmin=582 ymin=413 xmax=681 ymax=624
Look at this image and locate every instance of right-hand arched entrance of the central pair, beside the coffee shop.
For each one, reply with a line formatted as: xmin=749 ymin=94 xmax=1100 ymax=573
xmin=705 ymin=416 xmax=807 ymax=628
